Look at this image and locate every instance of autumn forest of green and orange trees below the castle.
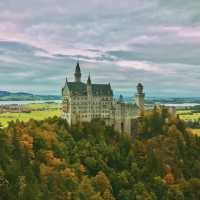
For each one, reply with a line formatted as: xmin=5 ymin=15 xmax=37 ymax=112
xmin=0 ymin=108 xmax=200 ymax=200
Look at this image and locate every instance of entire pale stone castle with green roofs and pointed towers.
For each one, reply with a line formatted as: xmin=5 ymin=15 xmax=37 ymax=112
xmin=62 ymin=62 xmax=145 ymax=134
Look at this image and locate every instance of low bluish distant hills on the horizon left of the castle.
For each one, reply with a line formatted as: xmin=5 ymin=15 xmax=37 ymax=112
xmin=0 ymin=91 xmax=61 ymax=101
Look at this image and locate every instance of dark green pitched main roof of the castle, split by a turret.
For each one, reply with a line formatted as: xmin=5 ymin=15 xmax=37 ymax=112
xmin=67 ymin=82 xmax=113 ymax=96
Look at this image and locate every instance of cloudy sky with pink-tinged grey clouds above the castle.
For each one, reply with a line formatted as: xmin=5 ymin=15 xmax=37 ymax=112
xmin=0 ymin=0 xmax=200 ymax=97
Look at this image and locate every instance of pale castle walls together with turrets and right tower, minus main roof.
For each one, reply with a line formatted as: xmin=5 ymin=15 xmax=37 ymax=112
xmin=62 ymin=65 xmax=144 ymax=134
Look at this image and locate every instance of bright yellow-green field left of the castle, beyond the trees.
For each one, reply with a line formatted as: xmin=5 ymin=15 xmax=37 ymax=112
xmin=0 ymin=103 xmax=61 ymax=127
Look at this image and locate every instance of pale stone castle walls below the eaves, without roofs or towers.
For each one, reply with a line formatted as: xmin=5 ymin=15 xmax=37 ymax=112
xmin=62 ymin=88 xmax=144 ymax=133
